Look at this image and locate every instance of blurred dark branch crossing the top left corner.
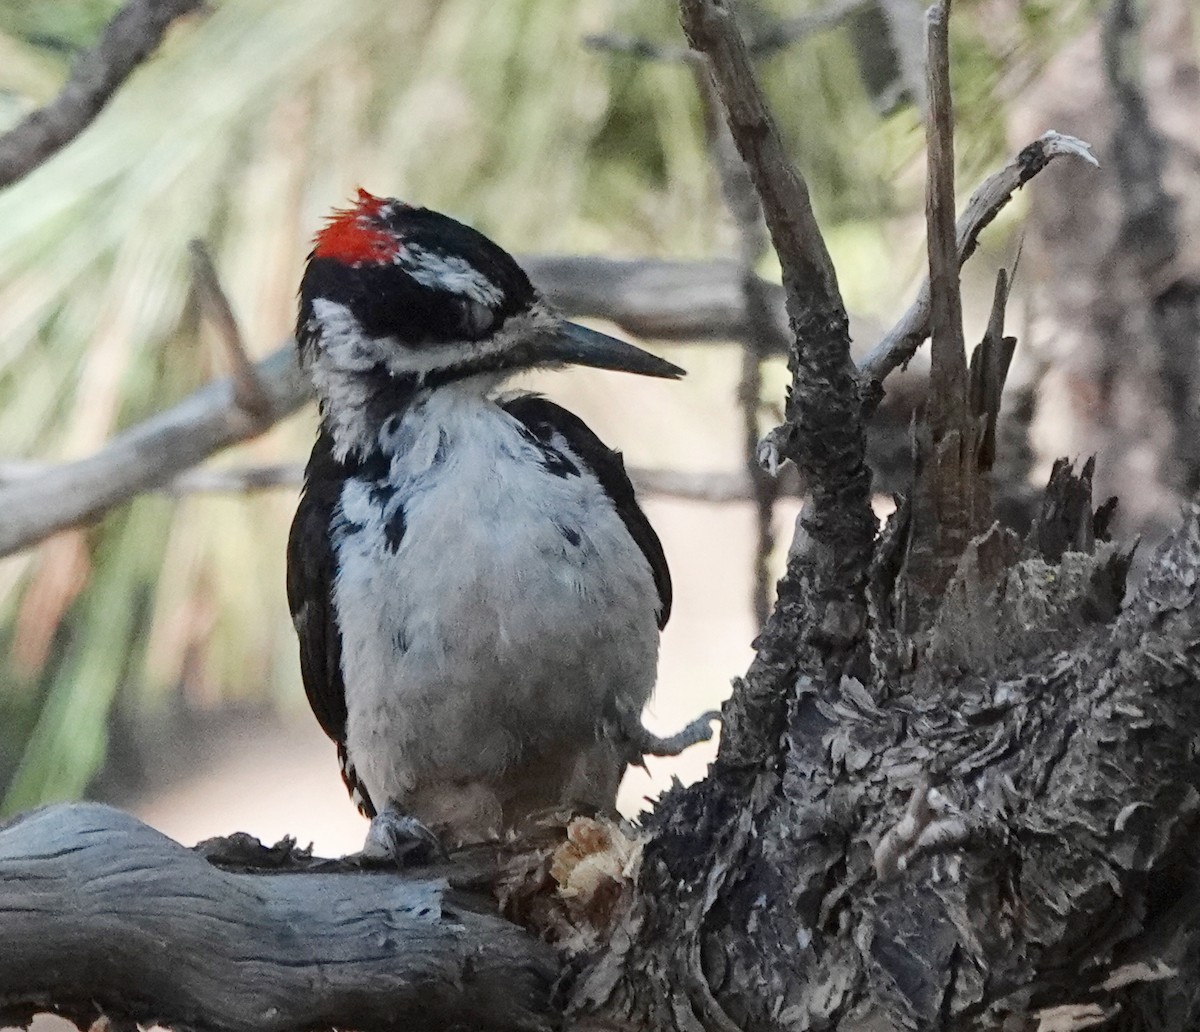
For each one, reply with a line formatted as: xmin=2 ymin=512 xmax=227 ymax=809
xmin=0 ymin=0 xmax=204 ymax=188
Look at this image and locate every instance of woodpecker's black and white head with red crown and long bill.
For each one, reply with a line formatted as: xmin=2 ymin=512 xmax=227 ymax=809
xmin=296 ymin=190 xmax=683 ymax=392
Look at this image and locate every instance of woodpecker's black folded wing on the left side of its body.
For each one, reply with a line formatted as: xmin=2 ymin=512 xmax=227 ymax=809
xmin=288 ymin=432 xmax=374 ymax=817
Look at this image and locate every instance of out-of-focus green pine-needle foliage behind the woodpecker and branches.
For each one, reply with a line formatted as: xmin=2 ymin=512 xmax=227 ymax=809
xmin=0 ymin=0 xmax=1099 ymax=810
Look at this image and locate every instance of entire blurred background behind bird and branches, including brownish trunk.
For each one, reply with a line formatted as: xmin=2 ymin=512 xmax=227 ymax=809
xmin=0 ymin=0 xmax=1200 ymax=853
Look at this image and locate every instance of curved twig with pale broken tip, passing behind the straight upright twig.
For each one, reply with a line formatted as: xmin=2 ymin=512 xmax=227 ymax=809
xmin=860 ymin=130 xmax=1099 ymax=396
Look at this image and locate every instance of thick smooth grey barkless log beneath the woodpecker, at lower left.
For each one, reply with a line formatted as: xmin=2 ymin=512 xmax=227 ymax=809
xmin=0 ymin=804 xmax=559 ymax=1032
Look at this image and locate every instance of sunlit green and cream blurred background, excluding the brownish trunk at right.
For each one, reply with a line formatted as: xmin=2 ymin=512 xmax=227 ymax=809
xmin=0 ymin=0 xmax=1113 ymax=852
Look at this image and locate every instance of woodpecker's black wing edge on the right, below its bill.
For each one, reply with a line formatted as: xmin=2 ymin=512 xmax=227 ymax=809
xmin=503 ymin=395 xmax=671 ymax=630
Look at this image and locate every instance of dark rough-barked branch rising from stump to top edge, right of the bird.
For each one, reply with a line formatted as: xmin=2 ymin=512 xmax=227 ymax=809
xmin=679 ymin=0 xmax=875 ymax=770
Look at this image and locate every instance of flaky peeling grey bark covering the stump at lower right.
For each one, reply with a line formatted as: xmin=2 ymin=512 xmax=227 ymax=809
xmin=577 ymin=453 xmax=1200 ymax=1032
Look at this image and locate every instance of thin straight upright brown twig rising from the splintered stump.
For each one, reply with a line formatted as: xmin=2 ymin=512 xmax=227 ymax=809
xmin=925 ymin=0 xmax=967 ymax=440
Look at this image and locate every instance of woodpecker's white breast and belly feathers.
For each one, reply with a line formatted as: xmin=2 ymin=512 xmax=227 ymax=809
xmin=335 ymin=386 xmax=659 ymax=808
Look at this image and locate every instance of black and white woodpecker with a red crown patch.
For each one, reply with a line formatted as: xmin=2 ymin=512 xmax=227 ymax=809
xmin=287 ymin=191 xmax=712 ymax=859
